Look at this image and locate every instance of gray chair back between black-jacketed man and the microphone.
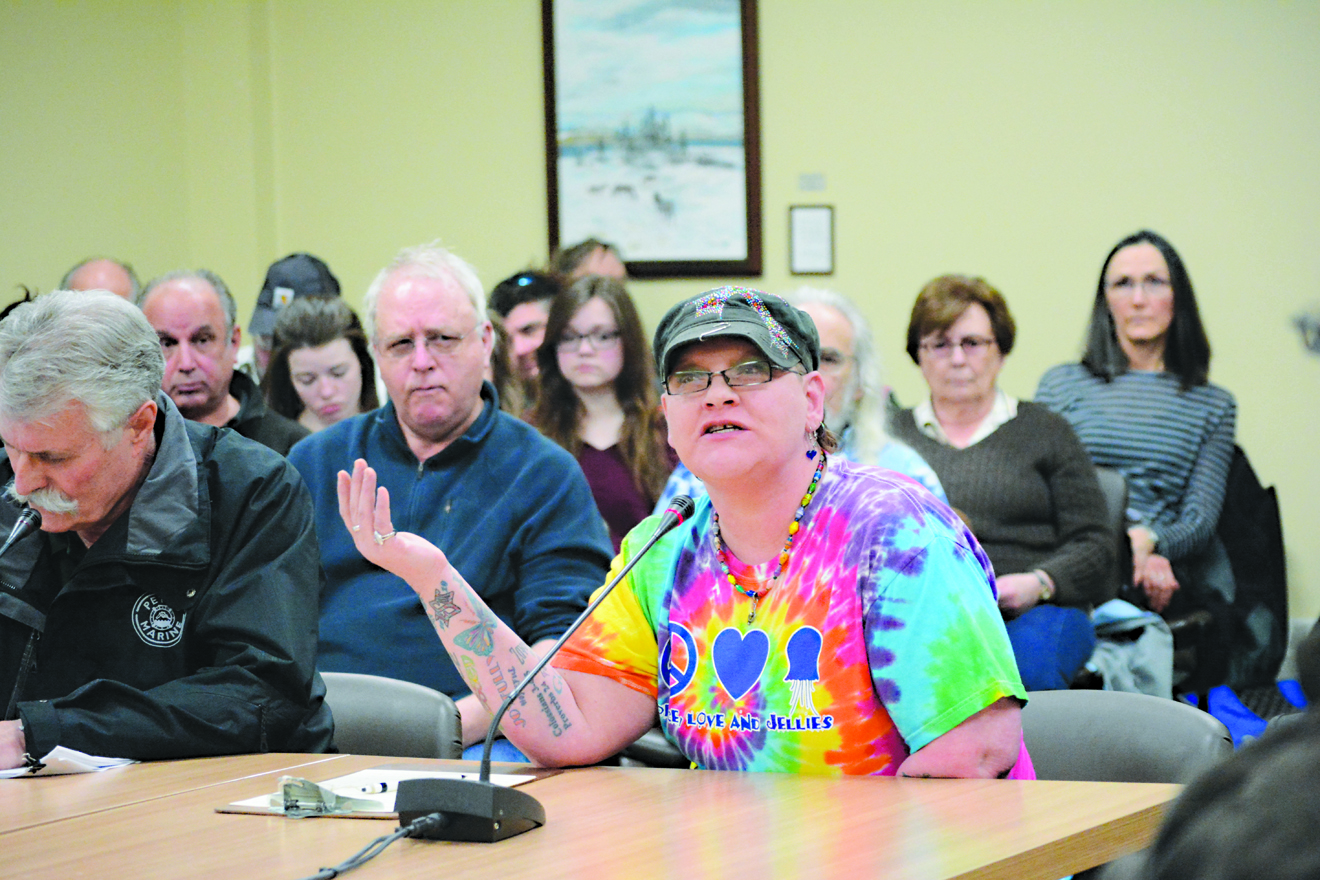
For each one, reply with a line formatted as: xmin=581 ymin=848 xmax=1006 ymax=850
xmin=321 ymin=673 xmax=463 ymax=759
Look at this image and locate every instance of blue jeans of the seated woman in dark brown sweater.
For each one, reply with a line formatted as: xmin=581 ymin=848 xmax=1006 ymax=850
xmin=1005 ymin=606 xmax=1096 ymax=690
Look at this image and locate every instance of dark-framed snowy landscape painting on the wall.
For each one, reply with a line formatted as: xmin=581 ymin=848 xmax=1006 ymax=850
xmin=541 ymin=0 xmax=763 ymax=278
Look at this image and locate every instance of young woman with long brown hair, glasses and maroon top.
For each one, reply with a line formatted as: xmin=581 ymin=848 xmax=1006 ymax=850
xmin=527 ymin=276 xmax=675 ymax=550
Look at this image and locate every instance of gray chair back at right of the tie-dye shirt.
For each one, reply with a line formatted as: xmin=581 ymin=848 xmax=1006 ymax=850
xmin=1022 ymin=690 xmax=1233 ymax=782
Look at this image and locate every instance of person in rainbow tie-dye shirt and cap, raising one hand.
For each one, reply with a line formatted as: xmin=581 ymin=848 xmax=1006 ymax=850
xmin=341 ymin=288 xmax=1032 ymax=778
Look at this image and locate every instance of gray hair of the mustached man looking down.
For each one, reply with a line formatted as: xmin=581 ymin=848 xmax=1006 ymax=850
xmin=0 ymin=290 xmax=165 ymax=439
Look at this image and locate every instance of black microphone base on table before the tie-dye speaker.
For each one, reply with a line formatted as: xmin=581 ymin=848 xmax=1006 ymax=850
xmin=395 ymin=780 xmax=545 ymax=843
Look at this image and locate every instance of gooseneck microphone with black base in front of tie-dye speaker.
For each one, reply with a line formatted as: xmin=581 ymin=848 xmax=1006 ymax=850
xmin=395 ymin=495 xmax=697 ymax=843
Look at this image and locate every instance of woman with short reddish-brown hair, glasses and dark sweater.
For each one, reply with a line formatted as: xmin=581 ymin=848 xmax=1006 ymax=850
xmin=894 ymin=274 xmax=1118 ymax=690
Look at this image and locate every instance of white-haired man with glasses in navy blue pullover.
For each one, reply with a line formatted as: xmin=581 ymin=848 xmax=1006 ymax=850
xmin=289 ymin=244 xmax=610 ymax=745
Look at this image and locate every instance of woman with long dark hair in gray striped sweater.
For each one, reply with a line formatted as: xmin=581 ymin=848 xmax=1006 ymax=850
xmin=1036 ymin=230 xmax=1237 ymax=664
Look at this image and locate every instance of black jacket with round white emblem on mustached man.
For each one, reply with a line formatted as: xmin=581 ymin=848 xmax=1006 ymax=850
xmin=0 ymin=394 xmax=333 ymax=759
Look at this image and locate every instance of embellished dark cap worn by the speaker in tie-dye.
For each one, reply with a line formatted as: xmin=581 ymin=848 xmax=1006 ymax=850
xmin=655 ymin=286 xmax=821 ymax=377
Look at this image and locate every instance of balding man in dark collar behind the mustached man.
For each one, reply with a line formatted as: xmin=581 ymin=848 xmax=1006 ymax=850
xmin=137 ymin=269 xmax=310 ymax=455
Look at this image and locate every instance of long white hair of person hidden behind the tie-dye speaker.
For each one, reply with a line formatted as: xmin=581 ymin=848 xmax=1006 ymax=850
xmin=784 ymin=288 xmax=890 ymax=462
